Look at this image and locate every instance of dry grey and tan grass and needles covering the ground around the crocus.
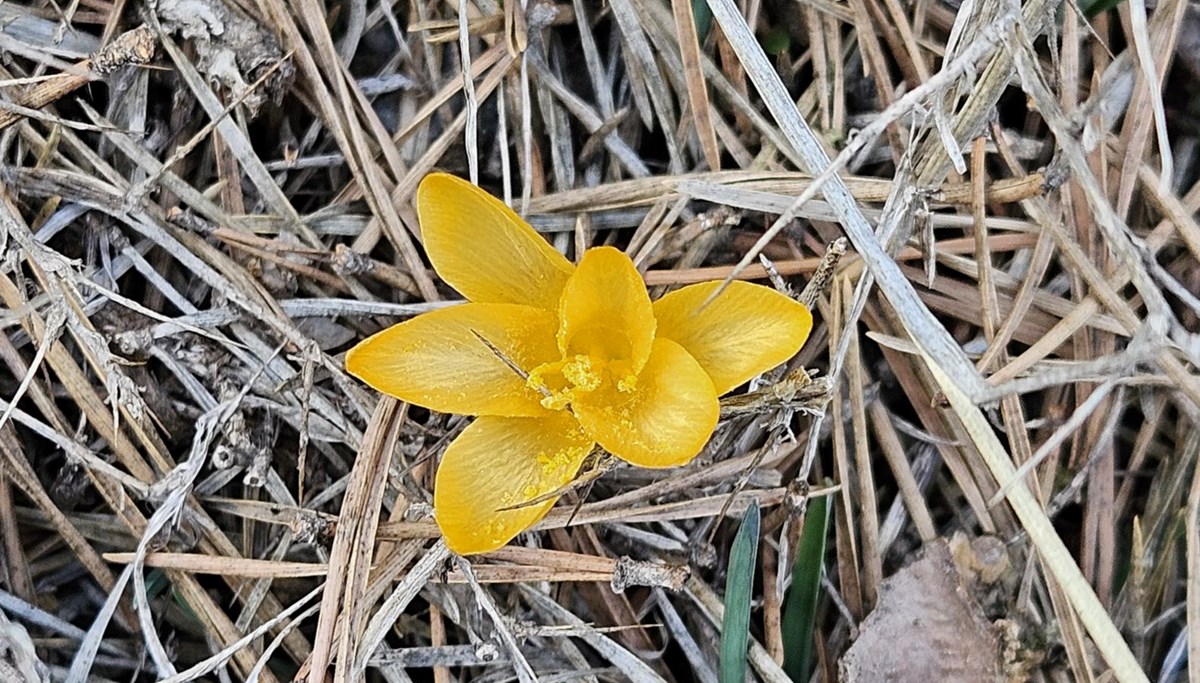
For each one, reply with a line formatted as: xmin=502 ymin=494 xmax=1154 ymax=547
xmin=0 ymin=0 xmax=1200 ymax=683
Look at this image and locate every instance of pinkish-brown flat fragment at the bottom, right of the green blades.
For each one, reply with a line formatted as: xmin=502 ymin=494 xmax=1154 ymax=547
xmin=839 ymin=543 xmax=1003 ymax=683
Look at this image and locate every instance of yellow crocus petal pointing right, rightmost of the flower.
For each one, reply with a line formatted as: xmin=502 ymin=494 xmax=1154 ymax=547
xmin=654 ymin=282 xmax=812 ymax=395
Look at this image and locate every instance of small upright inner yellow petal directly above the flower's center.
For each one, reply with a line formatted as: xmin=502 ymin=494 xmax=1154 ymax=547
xmin=558 ymin=246 xmax=654 ymax=375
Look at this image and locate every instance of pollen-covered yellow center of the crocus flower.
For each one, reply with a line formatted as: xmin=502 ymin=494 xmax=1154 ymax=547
xmin=526 ymin=328 xmax=637 ymax=411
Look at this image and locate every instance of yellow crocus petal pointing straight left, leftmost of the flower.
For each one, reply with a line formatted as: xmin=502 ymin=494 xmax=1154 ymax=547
xmin=346 ymin=304 xmax=558 ymax=417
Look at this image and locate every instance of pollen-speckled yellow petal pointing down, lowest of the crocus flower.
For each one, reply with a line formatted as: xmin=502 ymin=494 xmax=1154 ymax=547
xmin=433 ymin=413 xmax=593 ymax=555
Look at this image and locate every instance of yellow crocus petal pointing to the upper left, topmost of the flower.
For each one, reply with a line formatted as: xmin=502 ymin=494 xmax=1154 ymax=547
xmin=416 ymin=173 xmax=575 ymax=311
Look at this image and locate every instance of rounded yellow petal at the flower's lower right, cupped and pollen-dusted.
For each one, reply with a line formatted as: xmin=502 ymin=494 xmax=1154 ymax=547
xmin=572 ymin=338 xmax=720 ymax=467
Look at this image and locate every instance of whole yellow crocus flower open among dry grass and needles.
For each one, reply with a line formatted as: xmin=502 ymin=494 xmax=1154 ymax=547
xmin=346 ymin=173 xmax=812 ymax=555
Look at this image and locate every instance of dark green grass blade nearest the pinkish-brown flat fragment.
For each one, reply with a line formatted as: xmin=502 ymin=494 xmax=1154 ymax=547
xmin=782 ymin=496 xmax=830 ymax=681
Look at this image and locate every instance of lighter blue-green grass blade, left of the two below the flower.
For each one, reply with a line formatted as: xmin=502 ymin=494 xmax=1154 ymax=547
xmin=721 ymin=501 xmax=762 ymax=683
